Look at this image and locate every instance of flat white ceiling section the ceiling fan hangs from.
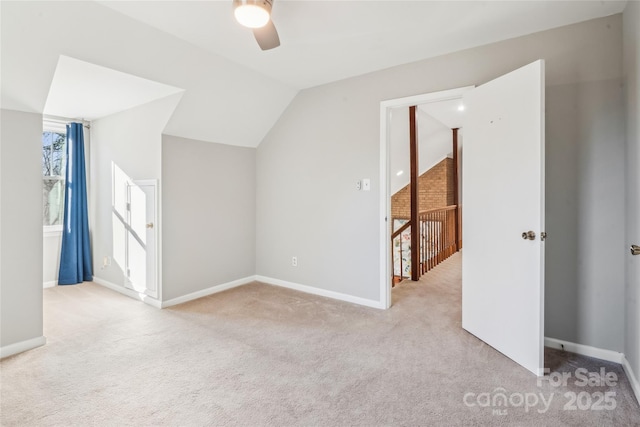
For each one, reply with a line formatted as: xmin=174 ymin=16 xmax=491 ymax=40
xmin=100 ymin=0 xmax=626 ymax=89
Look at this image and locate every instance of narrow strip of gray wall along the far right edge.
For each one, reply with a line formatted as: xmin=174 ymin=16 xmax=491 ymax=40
xmin=623 ymin=1 xmax=640 ymax=378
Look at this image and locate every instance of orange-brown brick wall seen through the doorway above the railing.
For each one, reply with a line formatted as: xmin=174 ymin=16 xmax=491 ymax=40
xmin=391 ymin=157 xmax=453 ymax=219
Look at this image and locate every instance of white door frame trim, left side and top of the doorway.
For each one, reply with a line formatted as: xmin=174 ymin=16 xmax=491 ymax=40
xmin=379 ymin=86 xmax=475 ymax=309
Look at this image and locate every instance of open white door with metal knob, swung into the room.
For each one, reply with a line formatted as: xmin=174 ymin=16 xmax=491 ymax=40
xmin=462 ymin=60 xmax=544 ymax=375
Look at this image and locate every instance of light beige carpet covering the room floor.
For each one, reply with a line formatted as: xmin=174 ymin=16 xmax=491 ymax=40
xmin=0 ymin=255 xmax=640 ymax=426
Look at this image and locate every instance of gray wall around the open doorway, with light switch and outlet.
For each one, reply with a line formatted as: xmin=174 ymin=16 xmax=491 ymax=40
xmin=257 ymin=15 xmax=624 ymax=351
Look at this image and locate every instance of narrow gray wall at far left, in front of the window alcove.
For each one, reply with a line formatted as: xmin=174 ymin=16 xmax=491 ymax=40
xmin=0 ymin=110 xmax=42 ymax=347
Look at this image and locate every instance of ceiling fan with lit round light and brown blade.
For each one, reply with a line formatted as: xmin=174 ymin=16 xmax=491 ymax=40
xmin=233 ymin=0 xmax=280 ymax=50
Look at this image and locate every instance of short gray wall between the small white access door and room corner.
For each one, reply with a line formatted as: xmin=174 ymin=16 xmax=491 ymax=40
xmin=161 ymin=135 xmax=256 ymax=301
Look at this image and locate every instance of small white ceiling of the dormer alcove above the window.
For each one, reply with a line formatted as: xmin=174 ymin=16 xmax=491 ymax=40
xmin=44 ymin=56 xmax=182 ymax=120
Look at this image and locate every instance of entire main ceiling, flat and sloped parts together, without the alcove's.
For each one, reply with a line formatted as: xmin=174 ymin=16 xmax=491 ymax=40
xmin=0 ymin=0 xmax=626 ymax=147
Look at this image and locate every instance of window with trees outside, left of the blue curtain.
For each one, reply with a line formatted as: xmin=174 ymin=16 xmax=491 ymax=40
xmin=42 ymin=124 xmax=67 ymax=228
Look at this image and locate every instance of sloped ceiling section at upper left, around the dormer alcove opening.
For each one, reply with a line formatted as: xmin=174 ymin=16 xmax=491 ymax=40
xmin=0 ymin=1 xmax=297 ymax=147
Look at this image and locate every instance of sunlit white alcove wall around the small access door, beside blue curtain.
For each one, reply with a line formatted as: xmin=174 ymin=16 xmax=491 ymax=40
xmin=89 ymin=94 xmax=182 ymax=286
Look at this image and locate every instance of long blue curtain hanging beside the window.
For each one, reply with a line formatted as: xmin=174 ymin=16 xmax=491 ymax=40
xmin=58 ymin=123 xmax=93 ymax=285
